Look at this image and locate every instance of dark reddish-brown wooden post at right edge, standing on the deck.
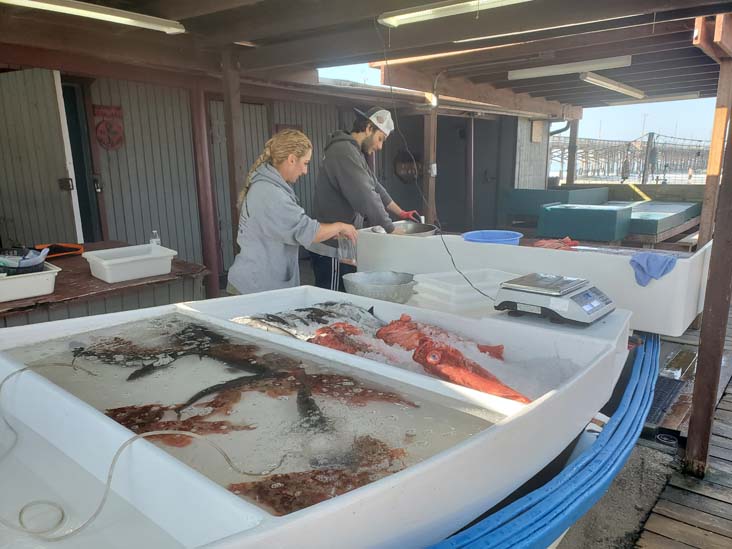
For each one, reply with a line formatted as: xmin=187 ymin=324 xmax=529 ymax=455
xmin=684 ymin=99 xmax=732 ymax=477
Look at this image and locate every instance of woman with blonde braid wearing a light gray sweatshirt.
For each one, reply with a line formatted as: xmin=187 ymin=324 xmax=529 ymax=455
xmin=227 ymin=129 xmax=356 ymax=294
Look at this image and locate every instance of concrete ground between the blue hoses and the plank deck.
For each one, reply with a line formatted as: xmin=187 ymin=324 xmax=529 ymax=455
xmin=558 ymin=441 xmax=680 ymax=549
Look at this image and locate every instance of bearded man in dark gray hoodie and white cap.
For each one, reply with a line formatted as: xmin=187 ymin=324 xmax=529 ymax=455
xmin=308 ymin=107 xmax=419 ymax=291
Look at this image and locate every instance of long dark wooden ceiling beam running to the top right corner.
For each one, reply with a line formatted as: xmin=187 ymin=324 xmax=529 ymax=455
xmin=233 ymin=0 xmax=729 ymax=69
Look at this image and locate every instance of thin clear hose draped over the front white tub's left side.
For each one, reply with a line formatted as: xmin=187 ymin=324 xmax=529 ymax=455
xmin=0 ymin=364 xmax=291 ymax=541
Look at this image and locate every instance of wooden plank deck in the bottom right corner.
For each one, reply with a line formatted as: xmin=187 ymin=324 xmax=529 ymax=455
xmin=636 ymin=382 xmax=732 ymax=549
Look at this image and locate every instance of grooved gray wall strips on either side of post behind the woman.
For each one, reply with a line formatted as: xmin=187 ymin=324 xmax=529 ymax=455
xmin=208 ymin=101 xmax=271 ymax=270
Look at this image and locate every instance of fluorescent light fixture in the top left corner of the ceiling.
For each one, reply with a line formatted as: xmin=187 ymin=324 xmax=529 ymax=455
xmin=0 ymin=0 xmax=186 ymax=34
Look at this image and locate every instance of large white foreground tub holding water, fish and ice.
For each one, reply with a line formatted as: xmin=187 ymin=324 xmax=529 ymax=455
xmin=0 ymin=287 xmax=630 ymax=548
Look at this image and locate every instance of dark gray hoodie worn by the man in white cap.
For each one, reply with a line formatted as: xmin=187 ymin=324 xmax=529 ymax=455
xmin=315 ymin=131 xmax=394 ymax=245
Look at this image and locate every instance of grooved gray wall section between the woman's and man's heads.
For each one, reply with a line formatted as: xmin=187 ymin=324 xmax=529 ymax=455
xmin=272 ymin=101 xmax=340 ymax=215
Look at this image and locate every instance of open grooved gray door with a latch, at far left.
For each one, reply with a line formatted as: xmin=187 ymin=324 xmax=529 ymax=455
xmin=0 ymin=69 xmax=77 ymax=246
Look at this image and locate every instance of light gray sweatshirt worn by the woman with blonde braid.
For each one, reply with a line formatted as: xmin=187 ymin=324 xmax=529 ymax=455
xmin=229 ymin=164 xmax=320 ymax=294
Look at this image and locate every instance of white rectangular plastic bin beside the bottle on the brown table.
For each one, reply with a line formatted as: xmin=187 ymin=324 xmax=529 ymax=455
xmin=81 ymin=244 xmax=178 ymax=284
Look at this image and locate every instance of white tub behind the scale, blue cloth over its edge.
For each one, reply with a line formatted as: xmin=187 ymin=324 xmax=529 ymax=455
xmin=358 ymin=231 xmax=712 ymax=337
